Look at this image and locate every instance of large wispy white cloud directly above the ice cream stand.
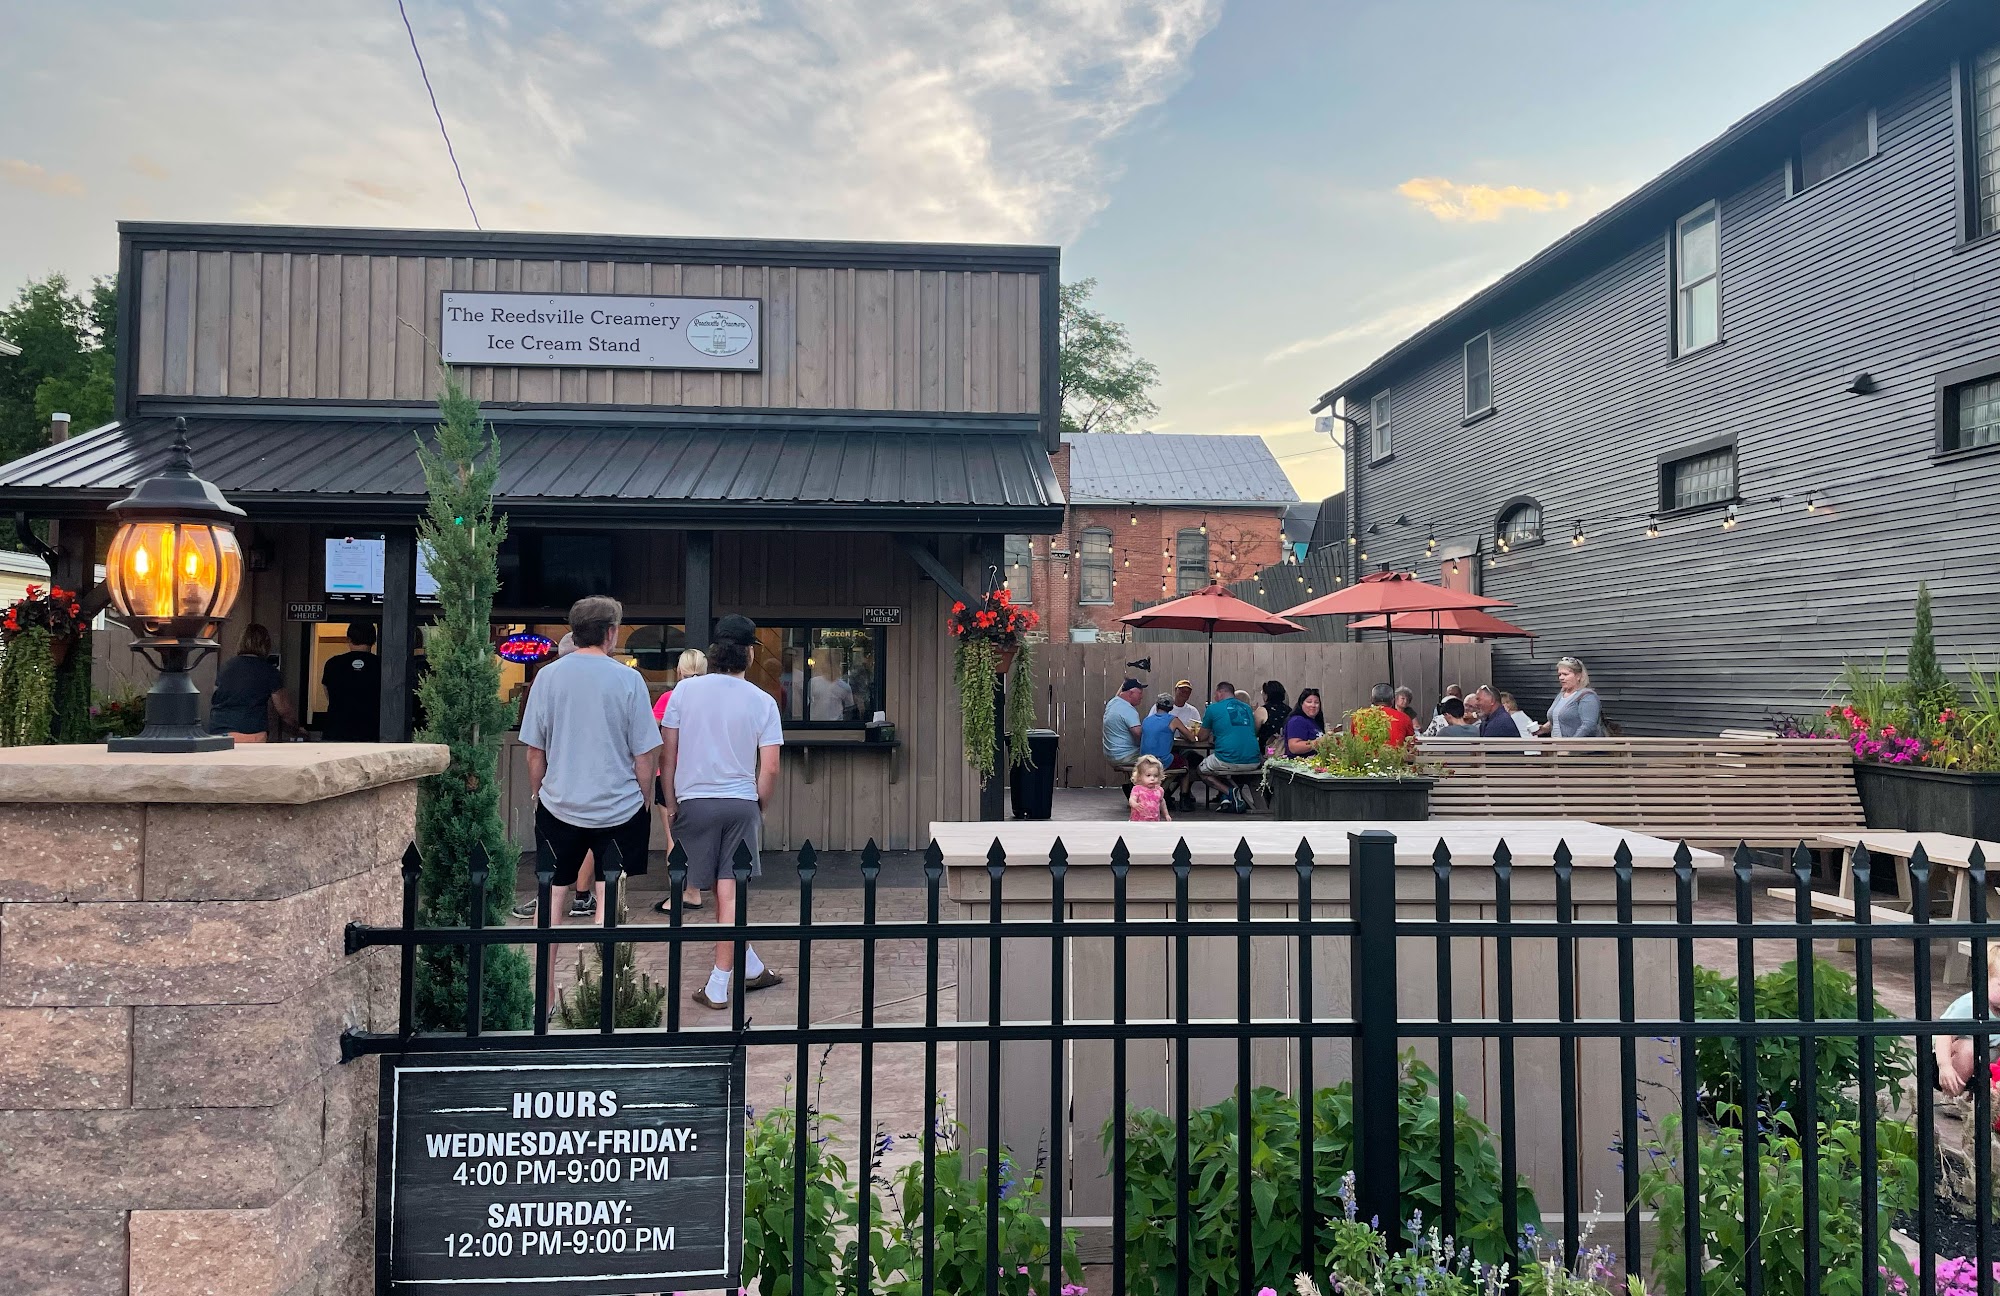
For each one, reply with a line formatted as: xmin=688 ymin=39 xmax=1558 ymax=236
xmin=0 ymin=0 xmax=1220 ymax=280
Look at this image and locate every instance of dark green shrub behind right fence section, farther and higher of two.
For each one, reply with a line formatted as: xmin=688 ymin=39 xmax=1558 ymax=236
xmin=1694 ymin=960 xmax=1916 ymax=1124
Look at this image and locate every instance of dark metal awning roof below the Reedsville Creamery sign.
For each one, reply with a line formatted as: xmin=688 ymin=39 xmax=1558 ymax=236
xmin=0 ymin=412 xmax=1062 ymax=530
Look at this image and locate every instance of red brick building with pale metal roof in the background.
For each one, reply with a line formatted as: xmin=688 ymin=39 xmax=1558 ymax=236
xmin=1004 ymin=432 xmax=1298 ymax=642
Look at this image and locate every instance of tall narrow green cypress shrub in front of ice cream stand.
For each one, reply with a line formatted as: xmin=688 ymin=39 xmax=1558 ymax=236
xmin=416 ymin=370 xmax=534 ymax=1030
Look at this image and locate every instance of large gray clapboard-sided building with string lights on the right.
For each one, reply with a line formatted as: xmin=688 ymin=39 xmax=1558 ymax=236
xmin=1314 ymin=0 xmax=2000 ymax=734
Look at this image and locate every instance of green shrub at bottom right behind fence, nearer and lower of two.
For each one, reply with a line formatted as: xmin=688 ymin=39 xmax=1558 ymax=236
xmin=1638 ymin=1108 xmax=1920 ymax=1296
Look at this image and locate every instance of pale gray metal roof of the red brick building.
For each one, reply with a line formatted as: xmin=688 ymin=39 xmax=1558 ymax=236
xmin=1062 ymin=432 xmax=1298 ymax=506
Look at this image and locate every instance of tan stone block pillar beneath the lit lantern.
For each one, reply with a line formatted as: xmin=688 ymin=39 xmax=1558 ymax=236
xmin=0 ymin=744 xmax=446 ymax=1296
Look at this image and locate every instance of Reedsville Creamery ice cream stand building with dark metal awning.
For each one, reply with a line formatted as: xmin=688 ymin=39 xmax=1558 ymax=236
xmin=0 ymin=224 xmax=1064 ymax=848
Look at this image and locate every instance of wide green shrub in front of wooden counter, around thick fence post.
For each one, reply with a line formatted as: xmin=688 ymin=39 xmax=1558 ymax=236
xmin=1104 ymin=1054 xmax=1542 ymax=1294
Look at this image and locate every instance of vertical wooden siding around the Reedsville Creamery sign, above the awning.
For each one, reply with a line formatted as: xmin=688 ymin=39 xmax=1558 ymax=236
xmin=134 ymin=248 xmax=1046 ymax=414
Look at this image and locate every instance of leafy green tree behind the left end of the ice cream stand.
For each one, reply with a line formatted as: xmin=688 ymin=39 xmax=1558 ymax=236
xmin=0 ymin=274 xmax=118 ymax=462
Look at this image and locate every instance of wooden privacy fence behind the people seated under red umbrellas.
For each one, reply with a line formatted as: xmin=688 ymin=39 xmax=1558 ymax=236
xmin=1034 ymin=636 xmax=1492 ymax=788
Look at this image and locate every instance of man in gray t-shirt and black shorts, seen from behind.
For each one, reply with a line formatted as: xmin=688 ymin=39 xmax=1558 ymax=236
xmin=520 ymin=598 xmax=660 ymax=952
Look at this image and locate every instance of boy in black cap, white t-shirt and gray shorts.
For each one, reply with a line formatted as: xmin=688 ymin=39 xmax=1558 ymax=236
xmin=660 ymin=614 xmax=784 ymax=1010
